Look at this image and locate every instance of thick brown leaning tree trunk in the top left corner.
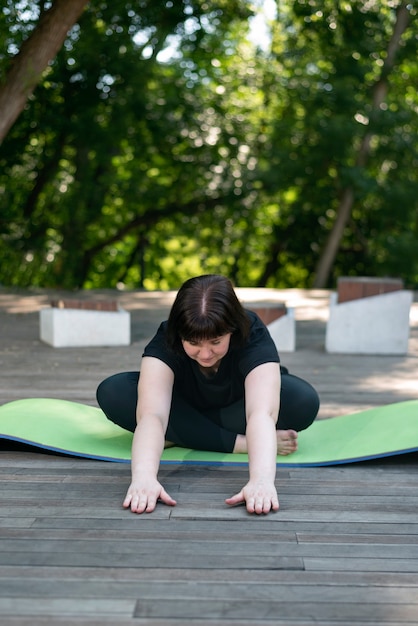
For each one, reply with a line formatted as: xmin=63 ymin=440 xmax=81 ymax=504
xmin=0 ymin=0 xmax=88 ymax=144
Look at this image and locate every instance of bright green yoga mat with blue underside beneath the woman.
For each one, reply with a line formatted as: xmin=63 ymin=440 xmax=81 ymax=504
xmin=0 ymin=398 xmax=418 ymax=467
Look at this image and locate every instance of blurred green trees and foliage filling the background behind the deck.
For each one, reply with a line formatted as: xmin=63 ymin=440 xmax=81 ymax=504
xmin=0 ymin=0 xmax=418 ymax=289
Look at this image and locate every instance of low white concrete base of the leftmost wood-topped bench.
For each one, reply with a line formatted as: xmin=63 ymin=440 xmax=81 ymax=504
xmin=39 ymin=307 xmax=131 ymax=348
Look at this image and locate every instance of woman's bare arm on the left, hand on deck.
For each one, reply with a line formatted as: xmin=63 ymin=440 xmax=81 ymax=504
xmin=123 ymin=357 xmax=176 ymax=513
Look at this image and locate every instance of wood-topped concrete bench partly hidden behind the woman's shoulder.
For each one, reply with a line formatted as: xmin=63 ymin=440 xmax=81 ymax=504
xmin=244 ymin=302 xmax=296 ymax=354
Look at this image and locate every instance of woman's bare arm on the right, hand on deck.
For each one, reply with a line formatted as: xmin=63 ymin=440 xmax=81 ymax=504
xmin=226 ymin=363 xmax=280 ymax=513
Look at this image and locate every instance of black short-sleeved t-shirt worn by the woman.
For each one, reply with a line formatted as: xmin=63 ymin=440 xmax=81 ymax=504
xmin=143 ymin=311 xmax=280 ymax=411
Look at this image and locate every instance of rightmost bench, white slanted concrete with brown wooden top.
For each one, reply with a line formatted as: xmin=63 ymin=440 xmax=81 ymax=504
xmin=325 ymin=277 xmax=412 ymax=355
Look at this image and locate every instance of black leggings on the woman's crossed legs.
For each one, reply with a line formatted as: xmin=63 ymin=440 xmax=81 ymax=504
xmin=97 ymin=371 xmax=319 ymax=452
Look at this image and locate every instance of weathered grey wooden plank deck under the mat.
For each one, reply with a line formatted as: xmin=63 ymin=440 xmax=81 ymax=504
xmin=0 ymin=290 xmax=418 ymax=626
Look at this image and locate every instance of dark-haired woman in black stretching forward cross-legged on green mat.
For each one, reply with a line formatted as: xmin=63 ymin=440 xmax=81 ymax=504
xmin=97 ymin=275 xmax=319 ymax=514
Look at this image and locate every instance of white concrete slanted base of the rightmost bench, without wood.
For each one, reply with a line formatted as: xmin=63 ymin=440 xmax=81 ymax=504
xmin=325 ymin=290 xmax=412 ymax=355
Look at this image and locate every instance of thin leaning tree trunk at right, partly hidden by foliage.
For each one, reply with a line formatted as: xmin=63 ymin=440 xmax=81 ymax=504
xmin=313 ymin=2 xmax=410 ymax=289
